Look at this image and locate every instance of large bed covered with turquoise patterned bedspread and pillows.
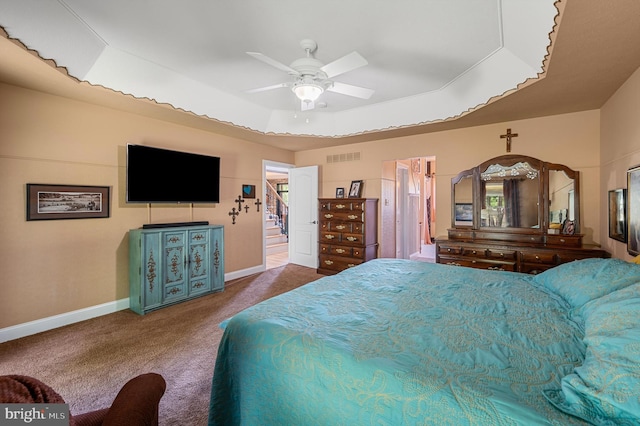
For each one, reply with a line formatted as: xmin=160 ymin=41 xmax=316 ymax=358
xmin=209 ymin=259 xmax=640 ymax=425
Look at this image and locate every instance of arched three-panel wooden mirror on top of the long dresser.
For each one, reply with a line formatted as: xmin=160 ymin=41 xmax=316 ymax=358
xmin=451 ymin=155 xmax=580 ymax=234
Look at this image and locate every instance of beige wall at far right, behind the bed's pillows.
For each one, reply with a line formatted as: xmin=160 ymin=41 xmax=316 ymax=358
xmin=600 ymin=69 xmax=640 ymax=260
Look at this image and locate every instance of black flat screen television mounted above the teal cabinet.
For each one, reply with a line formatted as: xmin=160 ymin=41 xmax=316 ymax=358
xmin=126 ymin=144 xmax=220 ymax=203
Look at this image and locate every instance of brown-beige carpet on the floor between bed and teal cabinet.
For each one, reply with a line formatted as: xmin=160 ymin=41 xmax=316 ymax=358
xmin=0 ymin=264 xmax=321 ymax=426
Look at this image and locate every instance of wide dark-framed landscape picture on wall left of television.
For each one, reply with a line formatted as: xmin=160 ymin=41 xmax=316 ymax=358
xmin=27 ymin=183 xmax=111 ymax=221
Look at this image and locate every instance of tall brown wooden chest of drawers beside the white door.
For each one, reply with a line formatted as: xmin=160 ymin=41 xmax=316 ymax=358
xmin=318 ymin=198 xmax=378 ymax=275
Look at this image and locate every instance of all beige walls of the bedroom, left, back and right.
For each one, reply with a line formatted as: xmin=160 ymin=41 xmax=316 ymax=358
xmin=0 ymin=62 xmax=640 ymax=329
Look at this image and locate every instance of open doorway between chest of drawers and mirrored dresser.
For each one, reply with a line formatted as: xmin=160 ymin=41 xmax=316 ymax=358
xmin=380 ymin=157 xmax=436 ymax=262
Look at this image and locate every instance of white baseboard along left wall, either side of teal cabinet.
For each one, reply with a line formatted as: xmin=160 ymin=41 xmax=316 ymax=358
xmin=0 ymin=265 xmax=266 ymax=343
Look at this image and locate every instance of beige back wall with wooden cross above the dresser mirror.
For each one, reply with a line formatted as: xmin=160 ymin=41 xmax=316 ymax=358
xmin=296 ymin=110 xmax=601 ymax=243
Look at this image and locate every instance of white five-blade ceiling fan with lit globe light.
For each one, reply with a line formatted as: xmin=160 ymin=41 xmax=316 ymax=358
xmin=247 ymin=39 xmax=374 ymax=111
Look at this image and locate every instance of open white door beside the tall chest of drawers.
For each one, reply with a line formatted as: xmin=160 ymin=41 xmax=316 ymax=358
xmin=289 ymin=166 xmax=318 ymax=268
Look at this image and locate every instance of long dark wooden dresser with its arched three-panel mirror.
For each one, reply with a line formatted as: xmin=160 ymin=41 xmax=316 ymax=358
xmin=436 ymin=155 xmax=609 ymax=274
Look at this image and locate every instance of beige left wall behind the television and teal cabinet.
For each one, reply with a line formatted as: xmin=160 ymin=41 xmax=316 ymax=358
xmin=0 ymin=84 xmax=293 ymax=328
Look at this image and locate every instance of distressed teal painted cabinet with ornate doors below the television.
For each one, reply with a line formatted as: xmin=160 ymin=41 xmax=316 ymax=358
xmin=129 ymin=225 xmax=224 ymax=315
